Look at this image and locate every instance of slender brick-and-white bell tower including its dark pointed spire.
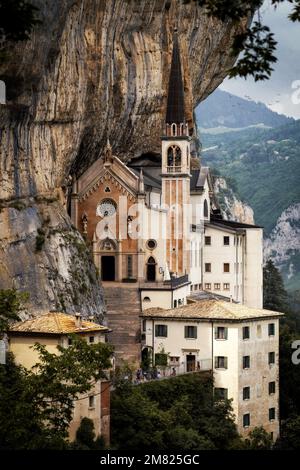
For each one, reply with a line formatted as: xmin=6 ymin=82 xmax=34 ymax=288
xmin=162 ymin=31 xmax=191 ymax=276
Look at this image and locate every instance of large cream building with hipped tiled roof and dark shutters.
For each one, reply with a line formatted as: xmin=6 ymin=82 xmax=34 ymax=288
xmin=141 ymin=299 xmax=283 ymax=440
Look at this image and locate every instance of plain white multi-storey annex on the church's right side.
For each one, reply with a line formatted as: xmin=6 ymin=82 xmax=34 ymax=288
xmin=203 ymin=217 xmax=263 ymax=307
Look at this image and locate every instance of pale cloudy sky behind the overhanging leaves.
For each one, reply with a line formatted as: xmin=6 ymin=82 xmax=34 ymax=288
xmin=220 ymin=0 xmax=300 ymax=119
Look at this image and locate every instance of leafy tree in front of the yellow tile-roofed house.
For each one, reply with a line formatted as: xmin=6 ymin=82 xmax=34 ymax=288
xmin=0 ymin=336 xmax=112 ymax=449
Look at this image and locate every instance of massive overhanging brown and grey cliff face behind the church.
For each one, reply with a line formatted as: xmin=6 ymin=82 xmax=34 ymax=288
xmin=0 ymin=0 xmax=247 ymax=313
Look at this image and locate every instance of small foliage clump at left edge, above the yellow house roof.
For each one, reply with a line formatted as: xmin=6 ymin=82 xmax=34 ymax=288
xmin=0 ymin=289 xmax=28 ymax=334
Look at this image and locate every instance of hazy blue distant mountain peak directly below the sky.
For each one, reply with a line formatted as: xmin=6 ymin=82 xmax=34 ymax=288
xmin=195 ymin=90 xmax=294 ymax=132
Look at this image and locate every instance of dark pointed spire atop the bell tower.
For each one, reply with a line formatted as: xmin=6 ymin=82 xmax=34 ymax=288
xmin=166 ymin=28 xmax=185 ymax=124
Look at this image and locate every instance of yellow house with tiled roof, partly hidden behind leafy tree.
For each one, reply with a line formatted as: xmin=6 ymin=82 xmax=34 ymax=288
xmin=9 ymin=312 xmax=110 ymax=444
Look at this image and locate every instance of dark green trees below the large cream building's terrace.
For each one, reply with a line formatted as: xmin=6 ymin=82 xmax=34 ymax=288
xmin=111 ymin=374 xmax=241 ymax=451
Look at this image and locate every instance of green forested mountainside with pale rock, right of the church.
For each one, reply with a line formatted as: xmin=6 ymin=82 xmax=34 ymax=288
xmin=200 ymin=120 xmax=300 ymax=289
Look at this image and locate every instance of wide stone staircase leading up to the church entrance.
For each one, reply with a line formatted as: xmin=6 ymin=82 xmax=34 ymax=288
xmin=102 ymin=282 xmax=141 ymax=364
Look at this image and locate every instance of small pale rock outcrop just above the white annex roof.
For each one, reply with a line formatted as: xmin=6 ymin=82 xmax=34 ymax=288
xmin=214 ymin=177 xmax=254 ymax=224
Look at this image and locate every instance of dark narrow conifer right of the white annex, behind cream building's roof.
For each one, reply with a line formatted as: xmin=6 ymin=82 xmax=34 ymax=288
xmin=263 ymin=259 xmax=289 ymax=312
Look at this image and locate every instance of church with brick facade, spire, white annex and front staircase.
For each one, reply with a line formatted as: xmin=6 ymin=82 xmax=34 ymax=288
xmin=71 ymin=33 xmax=262 ymax=362
